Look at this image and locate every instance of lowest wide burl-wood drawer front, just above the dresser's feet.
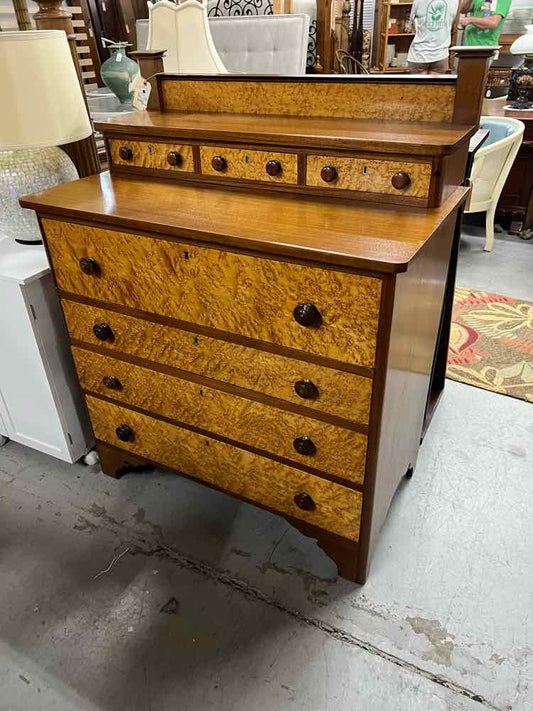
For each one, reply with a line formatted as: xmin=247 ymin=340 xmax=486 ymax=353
xmin=87 ymin=396 xmax=362 ymax=540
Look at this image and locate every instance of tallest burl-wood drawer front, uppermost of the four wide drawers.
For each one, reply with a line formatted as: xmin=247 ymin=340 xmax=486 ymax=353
xmin=43 ymin=219 xmax=381 ymax=367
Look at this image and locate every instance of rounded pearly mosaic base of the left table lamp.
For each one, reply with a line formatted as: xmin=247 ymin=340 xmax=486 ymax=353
xmin=0 ymin=146 xmax=78 ymax=244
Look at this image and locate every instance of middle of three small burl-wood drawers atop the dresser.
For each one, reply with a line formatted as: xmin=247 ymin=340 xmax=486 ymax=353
xmin=200 ymin=146 xmax=298 ymax=185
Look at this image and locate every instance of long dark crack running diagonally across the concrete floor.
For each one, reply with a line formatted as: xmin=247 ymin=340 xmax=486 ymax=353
xmin=128 ymin=542 xmax=504 ymax=711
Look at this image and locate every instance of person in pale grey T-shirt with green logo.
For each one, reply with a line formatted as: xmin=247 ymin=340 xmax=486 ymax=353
xmin=407 ymin=0 xmax=459 ymax=74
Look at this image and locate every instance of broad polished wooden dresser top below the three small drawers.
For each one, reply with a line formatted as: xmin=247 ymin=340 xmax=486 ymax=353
xmin=21 ymin=173 xmax=468 ymax=272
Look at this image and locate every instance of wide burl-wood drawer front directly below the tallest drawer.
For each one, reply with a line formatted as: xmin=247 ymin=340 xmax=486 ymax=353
xmin=62 ymin=299 xmax=372 ymax=424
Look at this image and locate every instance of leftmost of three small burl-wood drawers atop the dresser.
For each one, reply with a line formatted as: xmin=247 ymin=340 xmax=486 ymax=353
xmin=109 ymin=138 xmax=194 ymax=173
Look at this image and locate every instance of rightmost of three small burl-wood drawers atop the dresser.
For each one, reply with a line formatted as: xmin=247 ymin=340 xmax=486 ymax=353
xmin=306 ymin=155 xmax=431 ymax=199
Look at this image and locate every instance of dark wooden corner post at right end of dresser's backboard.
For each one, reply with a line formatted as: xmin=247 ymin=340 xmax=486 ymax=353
xmin=450 ymin=47 xmax=498 ymax=125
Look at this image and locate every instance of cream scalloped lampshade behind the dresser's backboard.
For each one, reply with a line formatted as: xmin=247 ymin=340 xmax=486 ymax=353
xmin=147 ymin=0 xmax=226 ymax=74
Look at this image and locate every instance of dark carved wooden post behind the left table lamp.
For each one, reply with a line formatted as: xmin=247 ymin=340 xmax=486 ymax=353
xmin=33 ymin=0 xmax=101 ymax=178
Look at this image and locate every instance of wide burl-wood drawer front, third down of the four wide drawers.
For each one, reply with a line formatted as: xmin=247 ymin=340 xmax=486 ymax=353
xmin=72 ymin=348 xmax=367 ymax=484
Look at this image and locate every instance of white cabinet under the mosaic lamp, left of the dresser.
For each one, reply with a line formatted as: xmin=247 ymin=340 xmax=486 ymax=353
xmin=0 ymin=236 xmax=93 ymax=462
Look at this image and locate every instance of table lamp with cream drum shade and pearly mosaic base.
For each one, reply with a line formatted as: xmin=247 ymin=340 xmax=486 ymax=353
xmin=0 ymin=30 xmax=92 ymax=244
